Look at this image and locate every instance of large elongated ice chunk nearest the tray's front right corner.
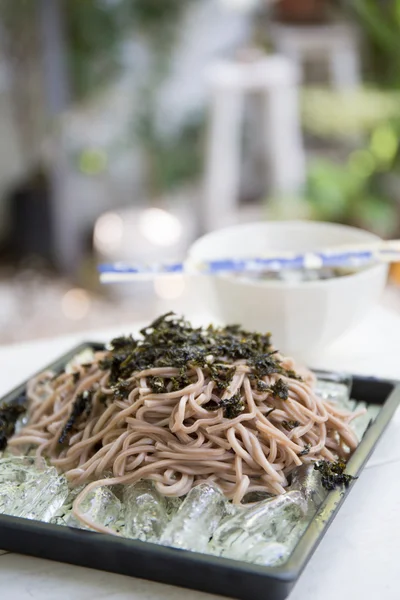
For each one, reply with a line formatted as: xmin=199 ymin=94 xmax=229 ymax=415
xmin=210 ymin=490 xmax=307 ymax=560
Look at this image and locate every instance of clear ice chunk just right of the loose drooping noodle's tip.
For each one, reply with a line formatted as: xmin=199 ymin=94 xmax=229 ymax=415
xmin=123 ymin=481 xmax=169 ymax=542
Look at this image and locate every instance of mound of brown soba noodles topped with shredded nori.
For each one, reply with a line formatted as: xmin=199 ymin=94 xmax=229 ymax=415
xmin=9 ymin=314 xmax=359 ymax=531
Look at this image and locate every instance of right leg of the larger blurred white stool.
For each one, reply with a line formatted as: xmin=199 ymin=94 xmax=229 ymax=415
xmin=265 ymin=85 xmax=305 ymax=195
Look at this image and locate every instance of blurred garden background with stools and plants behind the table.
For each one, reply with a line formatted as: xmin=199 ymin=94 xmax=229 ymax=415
xmin=0 ymin=0 xmax=400 ymax=343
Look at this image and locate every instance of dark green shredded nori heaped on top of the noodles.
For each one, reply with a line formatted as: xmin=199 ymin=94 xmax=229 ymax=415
xmin=100 ymin=312 xmax=297 ymax=386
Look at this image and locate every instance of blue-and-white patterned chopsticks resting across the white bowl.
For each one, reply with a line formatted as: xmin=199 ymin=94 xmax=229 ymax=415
xmin=98 ymin=240 xmax=400 ymax=283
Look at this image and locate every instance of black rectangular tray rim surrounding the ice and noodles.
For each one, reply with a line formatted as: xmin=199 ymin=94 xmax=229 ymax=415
xmin=0 ymin=341 xmax=400 ymax=598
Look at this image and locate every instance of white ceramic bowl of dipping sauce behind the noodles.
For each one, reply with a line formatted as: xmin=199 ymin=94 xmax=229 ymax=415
xmin=188 ymin=221 xmax=387 ymax=357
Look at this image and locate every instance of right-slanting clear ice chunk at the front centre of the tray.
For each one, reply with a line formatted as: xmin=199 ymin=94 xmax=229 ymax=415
xmin=160 ymin=483 xmax=227 ymax=552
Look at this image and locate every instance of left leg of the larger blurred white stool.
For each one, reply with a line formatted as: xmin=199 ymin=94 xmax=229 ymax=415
xmin=201 ymin=87 xmax=243 ymax=231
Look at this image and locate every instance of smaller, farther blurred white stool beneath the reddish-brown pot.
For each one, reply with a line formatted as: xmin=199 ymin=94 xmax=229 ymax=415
xmin=269 ymin=23 xmax=361 ymax=89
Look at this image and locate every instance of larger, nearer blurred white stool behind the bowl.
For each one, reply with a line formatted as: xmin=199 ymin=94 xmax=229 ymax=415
xmin=200 ymin=55 xmax=305 ymax=231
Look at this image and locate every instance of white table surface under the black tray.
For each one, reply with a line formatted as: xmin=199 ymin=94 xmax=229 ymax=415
xmin=0 ymin=307 xmax=400 ymax=600
